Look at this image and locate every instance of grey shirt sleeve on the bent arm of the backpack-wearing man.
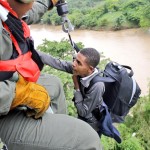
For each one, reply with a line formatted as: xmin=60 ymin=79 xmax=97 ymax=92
xmin=74 ymin=82 xmax=104 ymax=117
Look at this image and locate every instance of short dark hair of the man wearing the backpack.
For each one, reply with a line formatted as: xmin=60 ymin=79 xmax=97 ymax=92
xmin=80 ymin=48 xmax=100 ymax=68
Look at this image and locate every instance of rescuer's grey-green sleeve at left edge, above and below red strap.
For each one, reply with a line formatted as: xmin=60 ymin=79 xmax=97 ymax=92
xmin=0 ymin=19 xmax=17 ymax=116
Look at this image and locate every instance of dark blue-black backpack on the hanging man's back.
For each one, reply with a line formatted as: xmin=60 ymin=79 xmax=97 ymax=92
xmin=88 ymin=62 xmax=141 ymax=123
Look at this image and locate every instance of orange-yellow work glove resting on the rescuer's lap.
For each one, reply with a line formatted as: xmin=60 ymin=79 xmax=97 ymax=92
xmin=10 ymin=75 xmax=50 ymax=119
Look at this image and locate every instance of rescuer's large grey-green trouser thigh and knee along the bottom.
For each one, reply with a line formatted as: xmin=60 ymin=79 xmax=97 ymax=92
xmin=0 ymin=111 xmax=102 ymax=150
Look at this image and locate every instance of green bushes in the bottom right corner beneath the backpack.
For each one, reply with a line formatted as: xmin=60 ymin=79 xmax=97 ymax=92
xmin=102 ymin=96 xmax=150 ymax=150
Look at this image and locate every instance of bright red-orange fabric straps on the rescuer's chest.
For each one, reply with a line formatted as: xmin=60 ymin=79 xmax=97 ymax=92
xmin=0 ymin=0 xmax=40 ymax=82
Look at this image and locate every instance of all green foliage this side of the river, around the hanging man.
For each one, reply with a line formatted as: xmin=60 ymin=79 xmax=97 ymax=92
xmin=38 ymin=39 xmax=150 ymax=150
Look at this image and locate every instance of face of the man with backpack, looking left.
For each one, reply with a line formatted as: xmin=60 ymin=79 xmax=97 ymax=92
xmin=72 ymin=52 xmax=93 ymax=77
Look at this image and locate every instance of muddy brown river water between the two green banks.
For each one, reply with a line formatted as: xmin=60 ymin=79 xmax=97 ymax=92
xmin=30 ymin=25 xmax=150 ymax=95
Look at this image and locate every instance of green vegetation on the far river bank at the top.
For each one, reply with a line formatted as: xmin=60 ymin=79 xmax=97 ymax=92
xmin=42 ymin=0 xmax=150 ymax=30
